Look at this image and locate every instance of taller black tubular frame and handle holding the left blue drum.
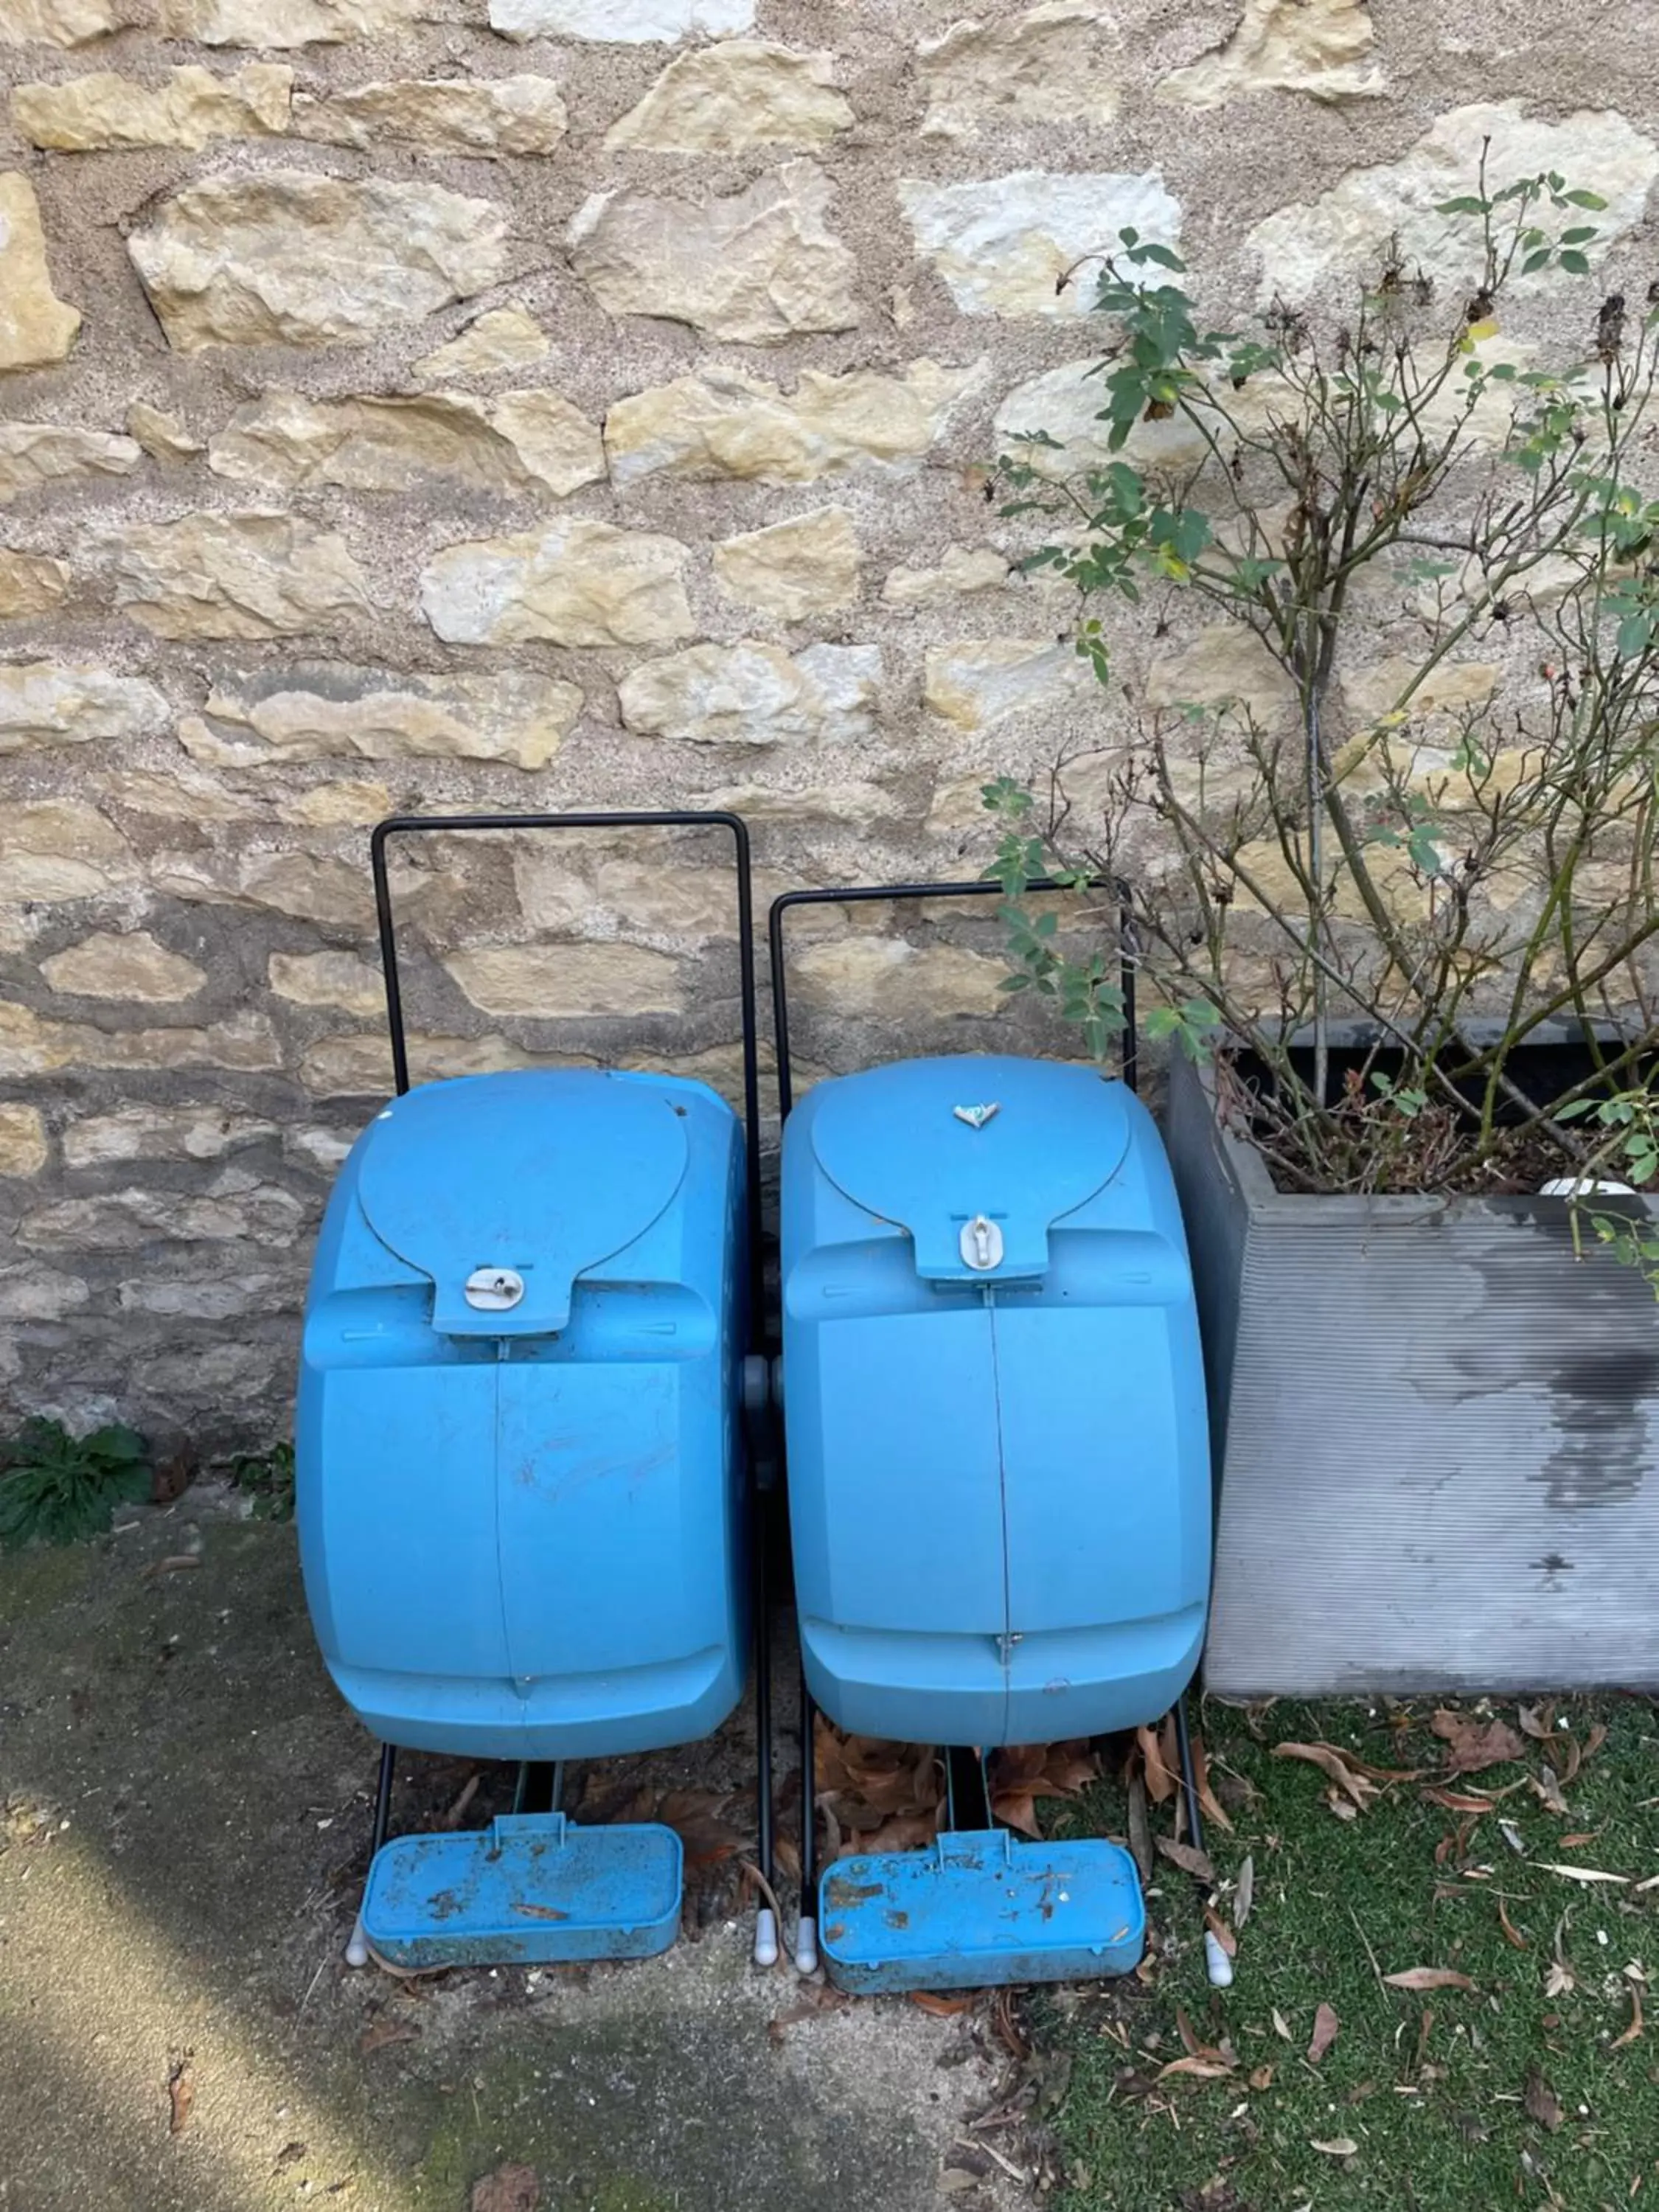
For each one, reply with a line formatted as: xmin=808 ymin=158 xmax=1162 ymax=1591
xmin=369 ymin=807 xmax=774 ymax=1920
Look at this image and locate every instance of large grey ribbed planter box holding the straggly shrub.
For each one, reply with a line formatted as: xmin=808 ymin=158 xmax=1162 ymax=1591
xmin=1166 ymin=1040 xmax=1659 ymax=1697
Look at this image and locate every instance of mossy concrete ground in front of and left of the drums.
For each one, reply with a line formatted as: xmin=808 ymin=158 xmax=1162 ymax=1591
xmin=0 ymin=1491 xmax=1035 ymax=2212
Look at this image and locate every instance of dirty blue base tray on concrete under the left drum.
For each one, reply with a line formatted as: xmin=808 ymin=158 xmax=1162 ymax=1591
xmin=363 ymin=1812 xmax=684 ymax=1966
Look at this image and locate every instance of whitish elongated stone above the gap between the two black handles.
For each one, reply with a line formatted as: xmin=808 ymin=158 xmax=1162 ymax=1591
xmin=617 ymin=639 xmax=880 ymax=745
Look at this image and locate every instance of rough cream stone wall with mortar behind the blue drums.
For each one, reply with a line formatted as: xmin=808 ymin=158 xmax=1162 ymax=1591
xmin=0 ymin=0 xmax=1659 ymax=1442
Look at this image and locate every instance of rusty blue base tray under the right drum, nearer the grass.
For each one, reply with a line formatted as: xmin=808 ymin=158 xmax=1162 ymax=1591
xmin=818 ymin=1827 xmax=1146 ymax=1995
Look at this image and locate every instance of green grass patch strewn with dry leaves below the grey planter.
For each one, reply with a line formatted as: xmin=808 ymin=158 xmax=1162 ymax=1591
xmin=1046 ymin=1697 xmax=1659 ymax=2212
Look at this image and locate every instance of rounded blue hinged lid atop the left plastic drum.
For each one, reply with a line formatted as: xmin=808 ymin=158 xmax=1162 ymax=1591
xmin=358 ymin=1068 xmax=688 ymax=1336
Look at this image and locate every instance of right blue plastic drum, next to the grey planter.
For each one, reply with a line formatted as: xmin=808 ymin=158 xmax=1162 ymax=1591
xmin=781 ymin=1057 xmax=1210 ymax=1745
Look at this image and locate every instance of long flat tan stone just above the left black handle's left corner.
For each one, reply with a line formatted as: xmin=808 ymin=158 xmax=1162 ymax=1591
xmin=179 ymin=661 xmax=582 ymax=770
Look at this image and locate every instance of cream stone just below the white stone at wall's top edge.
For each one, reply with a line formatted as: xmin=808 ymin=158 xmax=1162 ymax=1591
xmin=606 ymin=38 xmax=854 ymax=155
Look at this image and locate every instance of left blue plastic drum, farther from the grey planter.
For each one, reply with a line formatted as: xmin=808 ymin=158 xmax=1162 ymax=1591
xmin=296 ymin=1071 xmax=748 ymax=1759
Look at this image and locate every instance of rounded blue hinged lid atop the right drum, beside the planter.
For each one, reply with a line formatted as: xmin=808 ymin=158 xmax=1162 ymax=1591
xmin=812 ymin=1055 xmax=1128 ymax=1281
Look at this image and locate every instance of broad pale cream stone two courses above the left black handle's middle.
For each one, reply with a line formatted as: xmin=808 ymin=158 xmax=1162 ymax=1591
xmin=420 ymin=520 xmax=695 ymax=646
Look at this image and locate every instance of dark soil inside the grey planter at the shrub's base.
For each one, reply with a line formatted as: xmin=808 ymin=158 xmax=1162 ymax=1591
xmin=1217 ymin=1042 xmax=1659 ymax=1206
